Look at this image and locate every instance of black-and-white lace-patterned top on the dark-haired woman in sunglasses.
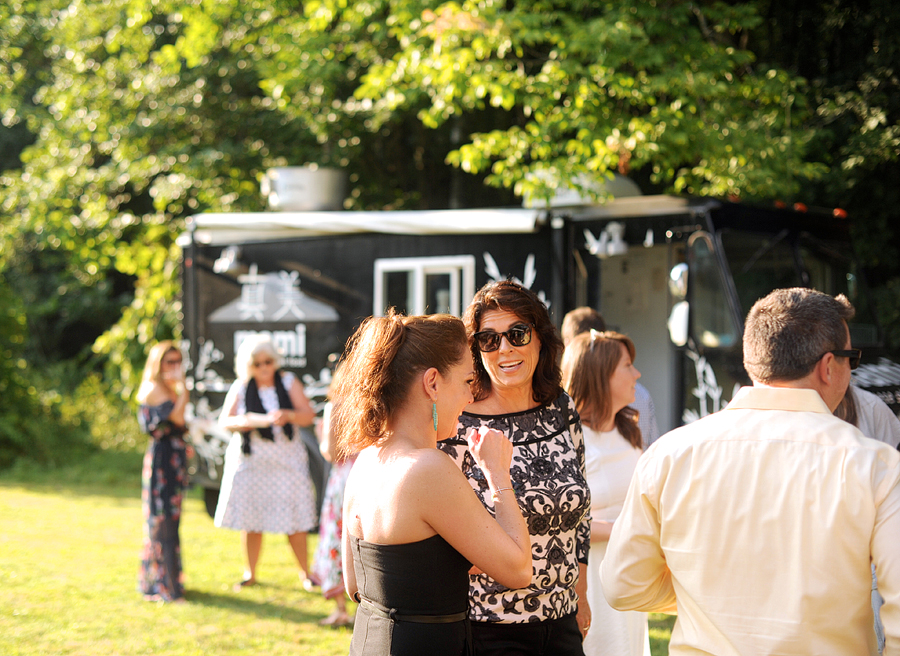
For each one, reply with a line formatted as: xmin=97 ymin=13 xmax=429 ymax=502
xmin=438 ymin=394 xmax=591 ymax=623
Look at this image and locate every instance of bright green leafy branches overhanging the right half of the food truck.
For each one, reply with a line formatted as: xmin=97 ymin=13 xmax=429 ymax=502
xmin=342 ymin=0 xmax=821 ymax=197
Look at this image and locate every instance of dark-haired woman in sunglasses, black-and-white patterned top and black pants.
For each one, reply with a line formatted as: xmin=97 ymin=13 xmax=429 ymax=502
xmin=438 ymin=281 xmax=591 ymax=656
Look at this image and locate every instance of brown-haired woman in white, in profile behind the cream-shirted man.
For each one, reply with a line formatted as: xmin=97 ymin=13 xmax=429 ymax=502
xmin=562 ymin=330 xmax=650 ymax=656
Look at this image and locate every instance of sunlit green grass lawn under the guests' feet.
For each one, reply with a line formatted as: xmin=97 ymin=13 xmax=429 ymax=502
xmin=0 ymin=452 xmax=673 ymax=656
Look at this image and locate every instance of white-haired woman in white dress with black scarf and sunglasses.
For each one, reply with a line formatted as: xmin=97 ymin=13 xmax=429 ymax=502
xmin=215 ymin=335 xmax=316 ymax=590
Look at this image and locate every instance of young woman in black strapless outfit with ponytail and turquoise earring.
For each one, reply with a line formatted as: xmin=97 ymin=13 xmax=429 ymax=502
xmin=333 ymin=314 xmax=531 ymax=656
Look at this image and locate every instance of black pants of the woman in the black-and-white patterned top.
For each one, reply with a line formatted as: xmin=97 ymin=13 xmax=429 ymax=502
xmin=472 ymin=613 xmax=584 ymax=656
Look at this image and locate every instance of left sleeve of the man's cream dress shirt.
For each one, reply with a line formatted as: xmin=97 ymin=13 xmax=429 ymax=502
xmin=600 ymin=455 xmax=676 ymax=613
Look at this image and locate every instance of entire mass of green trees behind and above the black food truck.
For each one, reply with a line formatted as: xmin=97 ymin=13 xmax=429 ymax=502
xmin=0 ymin=0 xmax=900 ymax=464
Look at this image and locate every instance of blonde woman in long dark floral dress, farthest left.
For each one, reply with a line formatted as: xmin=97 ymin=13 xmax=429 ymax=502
xmin=137 ymin=341 xmax=188 ymax=601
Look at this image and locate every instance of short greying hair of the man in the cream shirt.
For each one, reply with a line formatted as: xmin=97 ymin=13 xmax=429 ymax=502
xmin=744 ymin=287 xmax=855 ymax=383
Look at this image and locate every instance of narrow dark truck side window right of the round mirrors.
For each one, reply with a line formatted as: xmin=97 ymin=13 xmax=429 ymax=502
xmin=688 ymin=232 xmax=740 ymax=348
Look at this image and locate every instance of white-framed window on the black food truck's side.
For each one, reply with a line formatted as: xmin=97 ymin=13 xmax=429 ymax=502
xmin=373 ymin=255 xmax=475 ymax=316
